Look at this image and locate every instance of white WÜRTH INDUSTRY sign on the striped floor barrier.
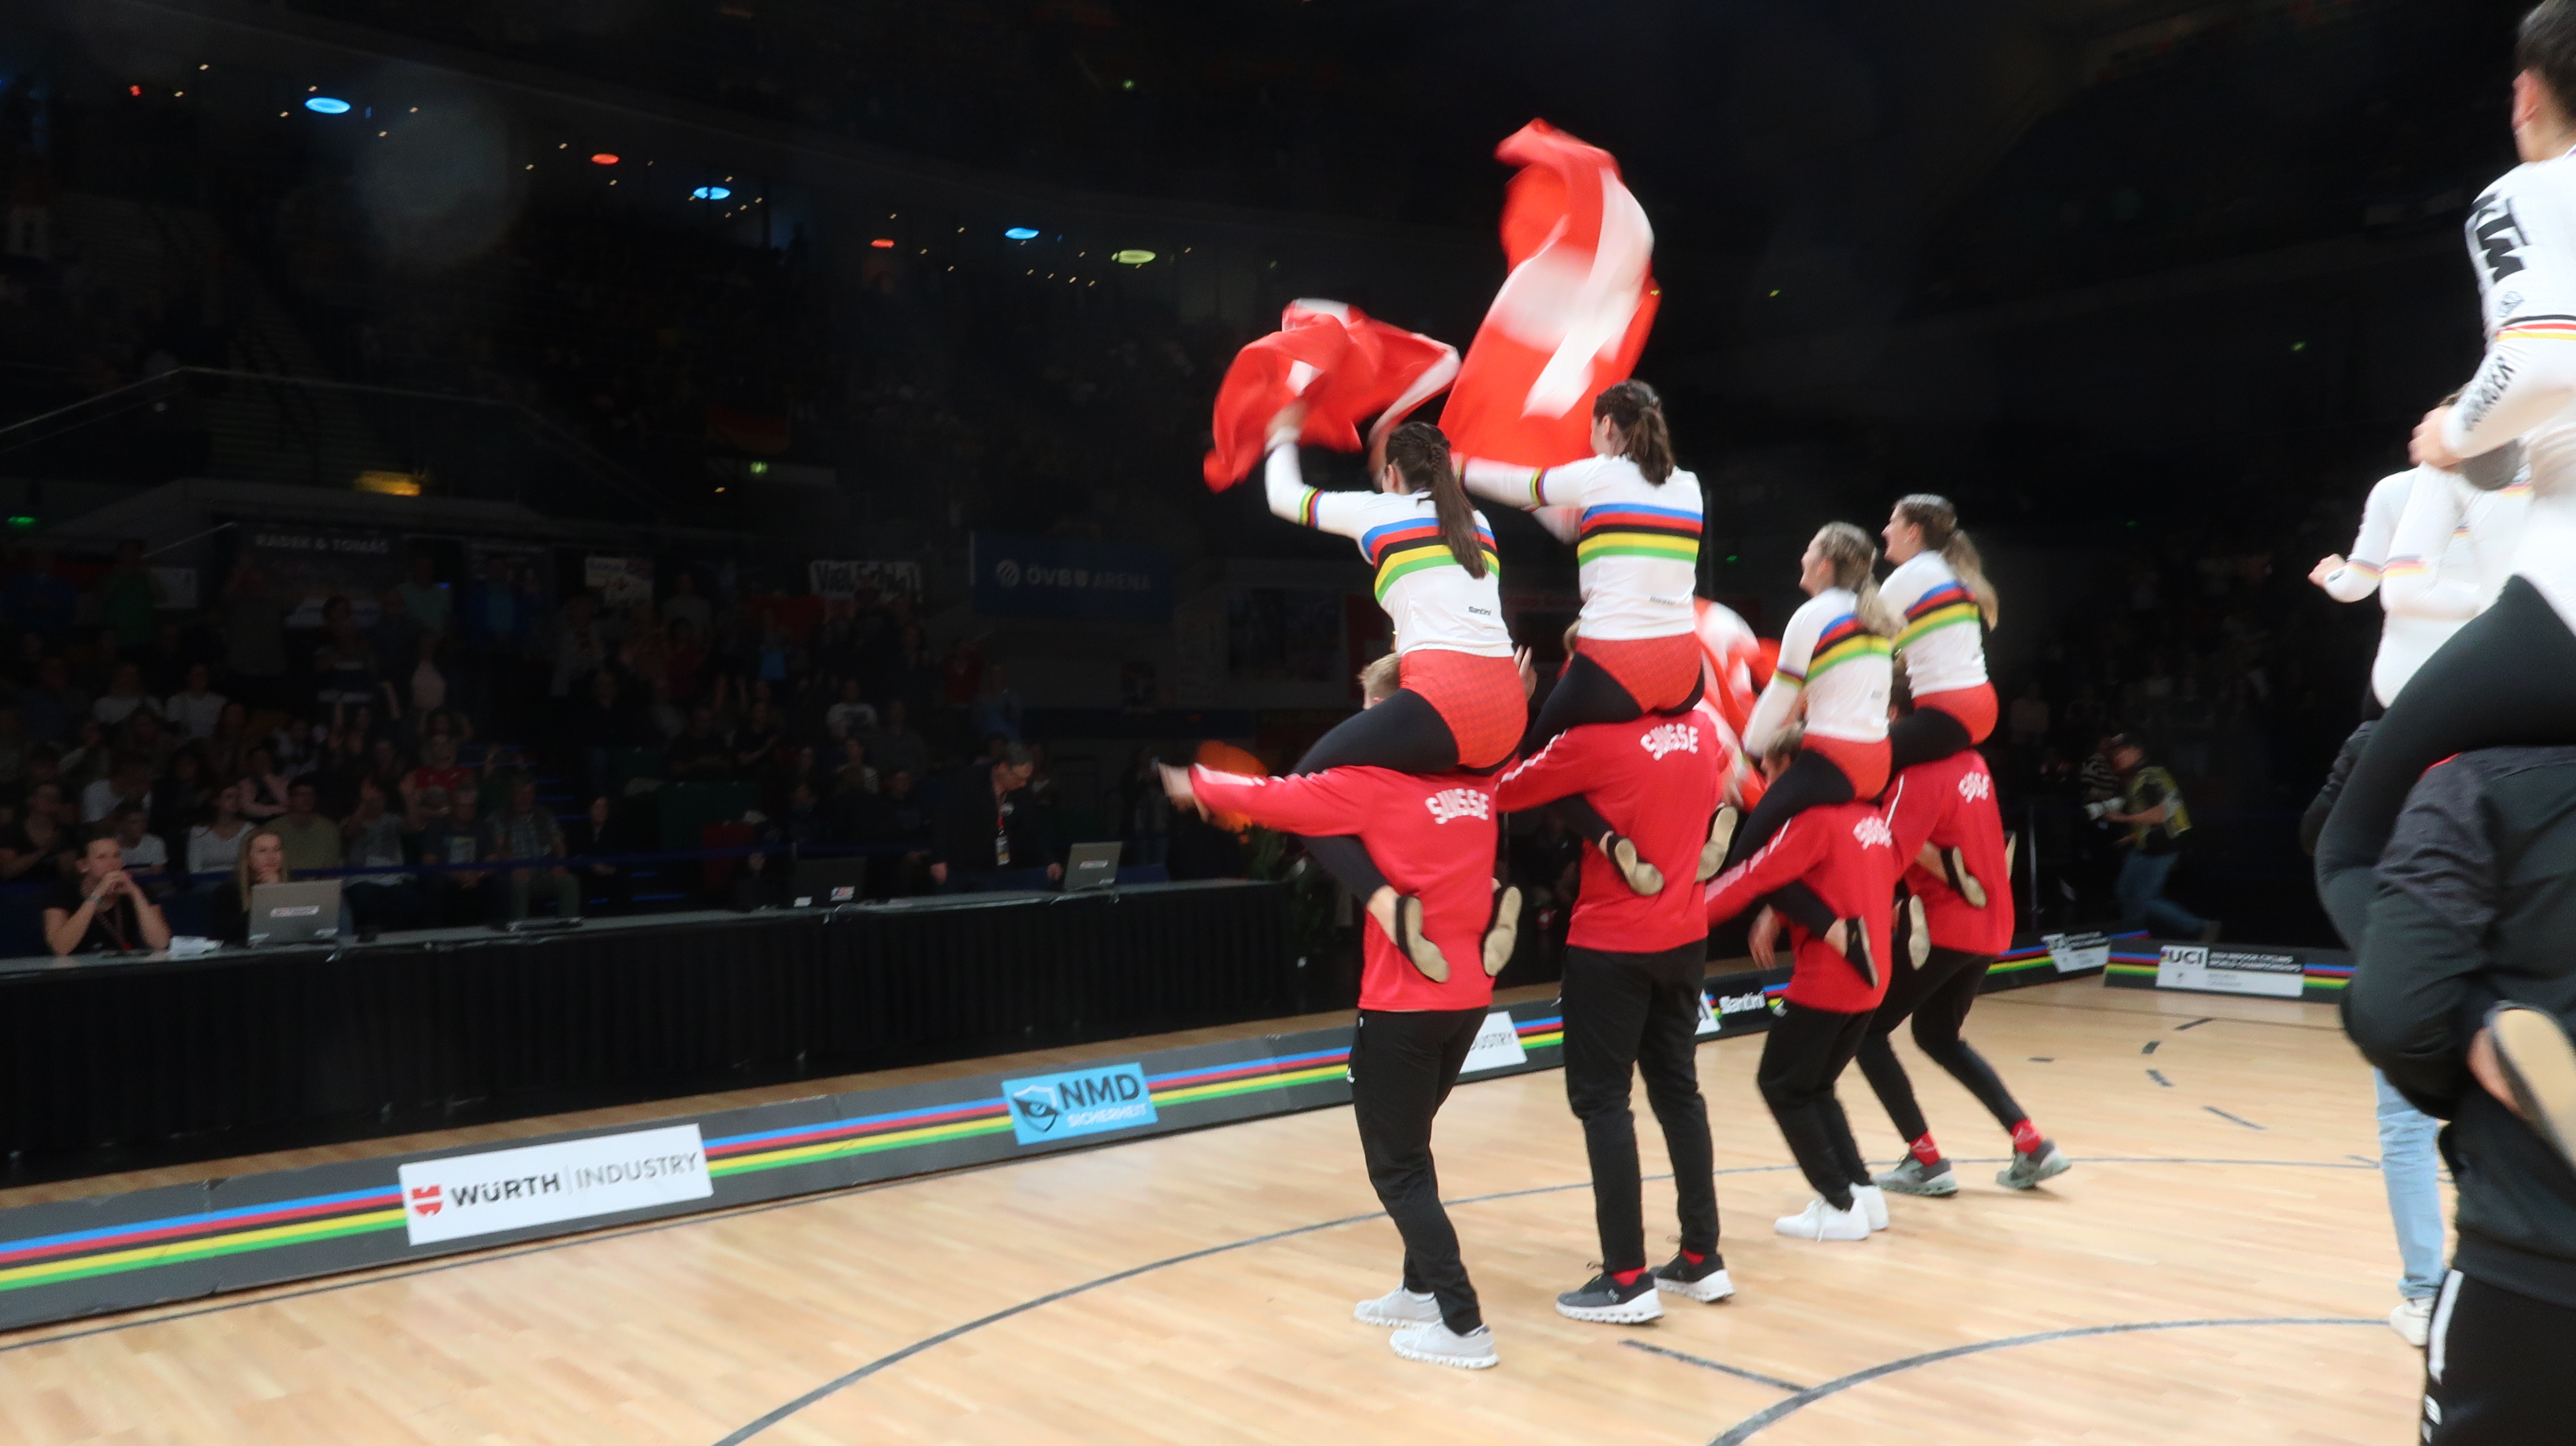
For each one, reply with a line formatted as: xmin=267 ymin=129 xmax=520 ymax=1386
xmin=399 ymin=1124 xmax=716 ymax=1245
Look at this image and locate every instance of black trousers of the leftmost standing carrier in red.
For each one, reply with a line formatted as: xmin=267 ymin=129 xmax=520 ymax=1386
xmin=1350 ymin=1005 xmax=1486 ymax=1335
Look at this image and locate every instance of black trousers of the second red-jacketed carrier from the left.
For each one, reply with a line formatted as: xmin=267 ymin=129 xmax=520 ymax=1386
xmin=1559 ymin=938 xmax=1718 ymax=1271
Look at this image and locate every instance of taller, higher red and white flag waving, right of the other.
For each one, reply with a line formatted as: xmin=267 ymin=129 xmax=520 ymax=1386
xmin=1440 ymin=121 xmax=1661 ymax=466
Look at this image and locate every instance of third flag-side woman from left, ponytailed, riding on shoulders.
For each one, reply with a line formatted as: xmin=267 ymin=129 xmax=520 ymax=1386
xmin=1726 ymin=523 xmax=1901 ymax=985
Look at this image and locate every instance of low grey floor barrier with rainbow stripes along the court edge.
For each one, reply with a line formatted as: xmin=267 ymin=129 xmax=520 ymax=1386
xmin=0 ymin=946 xmax=2112 ymax=1330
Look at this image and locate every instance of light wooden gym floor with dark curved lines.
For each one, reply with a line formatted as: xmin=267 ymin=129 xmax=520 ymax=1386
xmin=0 ymin=980 xmax=2422 ymax=1446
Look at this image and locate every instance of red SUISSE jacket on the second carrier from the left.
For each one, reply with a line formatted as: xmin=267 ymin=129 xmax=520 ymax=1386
xmin=1494 ymin=709 xmax=1726 ymax=954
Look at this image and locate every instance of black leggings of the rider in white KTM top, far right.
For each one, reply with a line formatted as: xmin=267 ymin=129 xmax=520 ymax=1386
xmin=2316 ymin=578 xmax=2576 ymax=948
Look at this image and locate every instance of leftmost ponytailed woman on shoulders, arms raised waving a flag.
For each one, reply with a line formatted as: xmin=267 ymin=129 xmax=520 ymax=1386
xmin=1262 ymin=407 xmax=1530 ymax=980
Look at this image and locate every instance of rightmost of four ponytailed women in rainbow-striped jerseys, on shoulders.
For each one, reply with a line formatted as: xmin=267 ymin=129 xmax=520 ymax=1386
xmin=1878 ymin=492 xmax=1999 ymax=773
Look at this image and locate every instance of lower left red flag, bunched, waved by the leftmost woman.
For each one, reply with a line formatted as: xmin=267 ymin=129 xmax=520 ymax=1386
xmin=1200 ymin=302 xmax=1458 ymax=492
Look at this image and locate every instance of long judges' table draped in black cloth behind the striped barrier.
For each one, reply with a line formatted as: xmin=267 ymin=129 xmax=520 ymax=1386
xmin=0 ymin=882 xmax=1301 ymax=1183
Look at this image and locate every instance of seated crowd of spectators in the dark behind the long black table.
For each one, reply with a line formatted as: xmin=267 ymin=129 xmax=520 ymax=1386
xmin=0 ymin=541 xmax=1118 ymax=954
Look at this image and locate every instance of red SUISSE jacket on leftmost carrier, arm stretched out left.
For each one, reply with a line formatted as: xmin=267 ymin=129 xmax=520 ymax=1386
xmin=1190 ymin=768 xmax=1497 ymax=1011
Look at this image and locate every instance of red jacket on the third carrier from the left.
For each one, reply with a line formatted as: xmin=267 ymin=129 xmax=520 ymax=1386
xmin=1705 ymin=804 xmax=1896 ymax=1013
